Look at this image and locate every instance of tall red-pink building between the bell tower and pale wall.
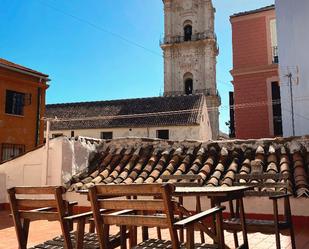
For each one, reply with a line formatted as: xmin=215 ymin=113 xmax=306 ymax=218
xmin=230 ymin=5 xmax=282 ymax=139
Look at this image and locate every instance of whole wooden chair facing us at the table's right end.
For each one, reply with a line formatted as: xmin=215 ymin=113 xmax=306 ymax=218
xmin=224 ymin=173 xmax=296 ymax=249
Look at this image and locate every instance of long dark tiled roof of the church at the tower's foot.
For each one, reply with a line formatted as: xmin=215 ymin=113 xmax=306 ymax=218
xmin=45 ymin=95 xmax=205 ymax=130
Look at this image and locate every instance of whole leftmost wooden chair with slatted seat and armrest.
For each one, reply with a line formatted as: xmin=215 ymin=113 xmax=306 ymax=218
xmin=8 ymin=186 xmax=120 ymax=249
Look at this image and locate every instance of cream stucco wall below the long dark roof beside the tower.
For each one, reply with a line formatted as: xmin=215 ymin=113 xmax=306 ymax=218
xmin=51 ymin=124 xmax=212 ymax=141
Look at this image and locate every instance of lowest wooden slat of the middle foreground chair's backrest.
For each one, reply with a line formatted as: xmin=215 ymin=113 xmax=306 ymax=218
xmin=102 ymin=215 xmax=168 ymax=228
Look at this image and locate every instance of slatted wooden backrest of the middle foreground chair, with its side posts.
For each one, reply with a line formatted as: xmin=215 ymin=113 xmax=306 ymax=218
xmin=89 ymin=184 xmax=179 ymax=248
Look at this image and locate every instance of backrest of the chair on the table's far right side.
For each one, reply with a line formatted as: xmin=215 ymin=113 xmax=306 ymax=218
xmin=234 ymin=173 xmax=289 ymax=196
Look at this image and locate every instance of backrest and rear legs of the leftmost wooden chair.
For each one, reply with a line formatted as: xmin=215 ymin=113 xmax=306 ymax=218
xmin=8 ymin=186 xmax=73 ymax=249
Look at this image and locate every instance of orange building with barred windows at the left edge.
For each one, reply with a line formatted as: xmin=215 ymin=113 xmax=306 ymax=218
xmin=0 ymin=59 xmax=49 ymax=162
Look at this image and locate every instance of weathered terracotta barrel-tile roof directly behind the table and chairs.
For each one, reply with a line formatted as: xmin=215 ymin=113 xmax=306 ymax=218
xmin=68 ymin=137 xmax=309 ymax=197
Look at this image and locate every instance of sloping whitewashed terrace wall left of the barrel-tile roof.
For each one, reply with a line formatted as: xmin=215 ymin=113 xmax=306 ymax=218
xmin=0 ymin=137 xmax=95 ymax=203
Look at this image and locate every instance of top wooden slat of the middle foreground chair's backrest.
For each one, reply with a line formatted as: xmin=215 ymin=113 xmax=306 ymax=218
xmin=94 ymin=184 xmax=171 ymax=196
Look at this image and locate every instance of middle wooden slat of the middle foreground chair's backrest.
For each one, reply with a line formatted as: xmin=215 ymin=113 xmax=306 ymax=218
xmin=99 ymin=199 xmax=164 ymax=211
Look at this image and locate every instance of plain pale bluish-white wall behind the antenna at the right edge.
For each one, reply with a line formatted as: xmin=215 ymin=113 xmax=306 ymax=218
xmin=276 ymin=0 xmax=309 ymax=136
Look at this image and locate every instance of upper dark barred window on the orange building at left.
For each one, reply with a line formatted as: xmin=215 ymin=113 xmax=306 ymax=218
xmin=5 ymin=90 xmax=25 ymax=116
